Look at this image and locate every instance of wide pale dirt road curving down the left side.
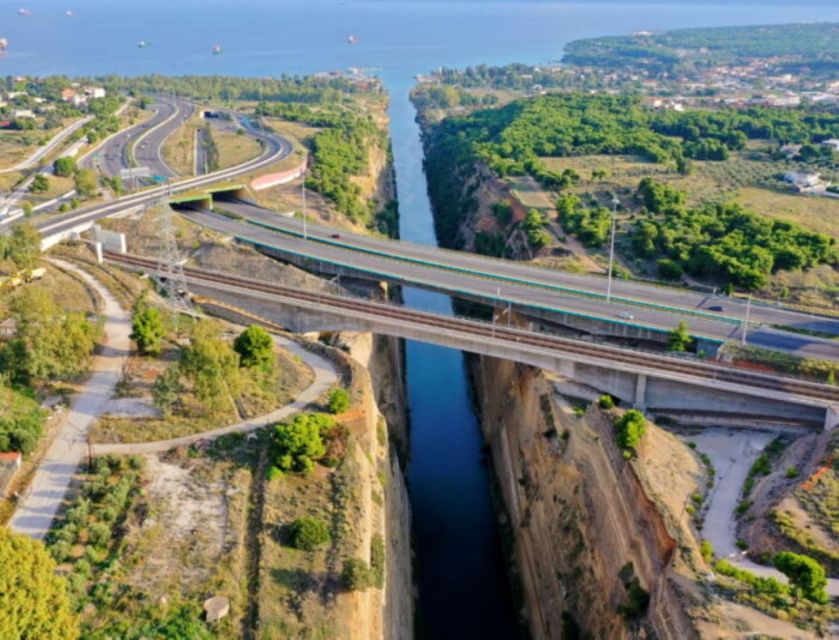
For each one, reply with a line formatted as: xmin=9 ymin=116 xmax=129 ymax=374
xmin=9 ymin=259 xmax=131 ymax=538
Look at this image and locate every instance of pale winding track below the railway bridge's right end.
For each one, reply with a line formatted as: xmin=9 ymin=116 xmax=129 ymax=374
xmin=686 ymin=428 xmax=839 ymax=597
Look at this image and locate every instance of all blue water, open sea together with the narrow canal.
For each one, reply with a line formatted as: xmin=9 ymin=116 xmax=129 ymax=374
xmin=6 ymin=0 xmax=839 ymax=640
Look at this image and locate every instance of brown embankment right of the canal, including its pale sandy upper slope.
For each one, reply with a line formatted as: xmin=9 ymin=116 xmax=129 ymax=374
xmin=469 ymin=357 xmax=820 ymax=640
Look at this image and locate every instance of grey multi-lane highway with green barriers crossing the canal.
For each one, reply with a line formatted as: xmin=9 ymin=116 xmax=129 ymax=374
xmin=188 ymin=206 xmax=839 ymax=360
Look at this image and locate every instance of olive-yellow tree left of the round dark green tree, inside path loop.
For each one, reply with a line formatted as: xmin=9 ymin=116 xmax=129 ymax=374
xmin=179 ymin=320 xmax=239 ymax=414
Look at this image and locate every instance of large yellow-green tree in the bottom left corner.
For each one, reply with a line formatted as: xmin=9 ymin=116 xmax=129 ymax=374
xmin=0 ymin=527 xmax=79 ymax=640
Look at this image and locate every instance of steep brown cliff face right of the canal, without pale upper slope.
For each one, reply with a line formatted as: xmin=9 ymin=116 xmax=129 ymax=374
xmin=472 ymin=358 xmax=698 ymax=639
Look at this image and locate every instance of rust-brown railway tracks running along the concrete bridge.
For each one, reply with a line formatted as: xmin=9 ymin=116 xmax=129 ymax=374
xmin=105 ymin=252 xmax=839 ymax=403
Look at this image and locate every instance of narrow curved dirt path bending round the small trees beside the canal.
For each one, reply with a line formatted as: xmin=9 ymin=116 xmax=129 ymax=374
xmin=93 ymin=336 xmax=338 ymax=455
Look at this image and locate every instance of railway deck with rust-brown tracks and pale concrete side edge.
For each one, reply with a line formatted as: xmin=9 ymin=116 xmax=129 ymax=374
xmin=105 ymin=252 xmax=839 ymax=407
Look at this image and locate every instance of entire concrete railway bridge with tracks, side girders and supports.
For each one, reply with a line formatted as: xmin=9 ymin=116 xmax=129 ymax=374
xmin=106 ymin=253 xmax=839 ymax=428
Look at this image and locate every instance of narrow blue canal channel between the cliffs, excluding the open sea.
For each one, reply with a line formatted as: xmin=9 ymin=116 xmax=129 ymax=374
xmin=390 ymin=77 xmax=516 ymax=640
